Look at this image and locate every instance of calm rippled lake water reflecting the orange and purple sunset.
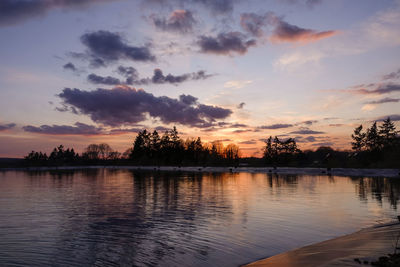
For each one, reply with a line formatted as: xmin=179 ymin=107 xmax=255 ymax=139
xmin=0 ymin=169 xmax=400 ymax=266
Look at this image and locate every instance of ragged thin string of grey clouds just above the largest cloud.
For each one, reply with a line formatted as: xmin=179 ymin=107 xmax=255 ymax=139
xmin=88 ymin=66 xmax=213 ymax=85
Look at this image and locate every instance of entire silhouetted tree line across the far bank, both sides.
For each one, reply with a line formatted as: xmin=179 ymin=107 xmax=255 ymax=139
xmin=20 ymin=118 xmax=400 ymax=168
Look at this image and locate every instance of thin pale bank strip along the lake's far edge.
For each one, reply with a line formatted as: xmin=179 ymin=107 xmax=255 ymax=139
xmin=0 ymin=165 xmax=400 ymax=177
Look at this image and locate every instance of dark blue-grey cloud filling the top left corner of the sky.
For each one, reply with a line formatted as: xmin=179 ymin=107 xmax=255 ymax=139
xmin=0 ymin=0 xmax=117 ymax=26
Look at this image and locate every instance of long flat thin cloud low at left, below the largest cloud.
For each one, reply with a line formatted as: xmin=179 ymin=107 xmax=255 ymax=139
xmin=22 ymin=122 xmax=103 ymax=135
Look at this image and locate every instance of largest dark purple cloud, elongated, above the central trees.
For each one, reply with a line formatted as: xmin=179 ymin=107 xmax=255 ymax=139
xmin=58 ymin=86 xmax=232 ymax=127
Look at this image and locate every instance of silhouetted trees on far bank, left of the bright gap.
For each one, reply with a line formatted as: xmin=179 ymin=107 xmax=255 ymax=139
xmin=24 ymin=127 xmax=240 ymax=166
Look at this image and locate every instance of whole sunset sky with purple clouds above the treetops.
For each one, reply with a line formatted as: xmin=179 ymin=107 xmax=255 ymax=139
xmin=0 ymin=0 xmax=400 ymax=157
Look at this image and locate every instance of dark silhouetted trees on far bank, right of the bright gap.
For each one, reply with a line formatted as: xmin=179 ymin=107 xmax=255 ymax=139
xmin=263 ymin=118 xmax=400 ymax=168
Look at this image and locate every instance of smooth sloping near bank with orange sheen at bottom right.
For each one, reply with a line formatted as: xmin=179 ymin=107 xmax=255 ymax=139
xmin=242 ymin=222 xmax=400 ymax=267
